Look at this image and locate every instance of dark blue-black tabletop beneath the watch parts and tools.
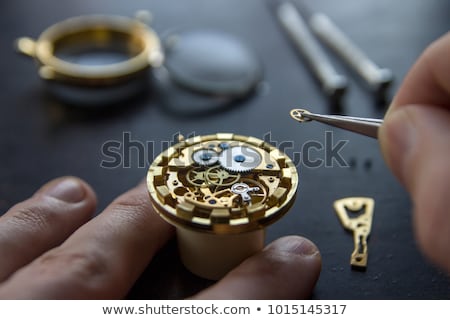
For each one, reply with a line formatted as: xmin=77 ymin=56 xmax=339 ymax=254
xmin=0 ymin=0 xmax=450 ymax=299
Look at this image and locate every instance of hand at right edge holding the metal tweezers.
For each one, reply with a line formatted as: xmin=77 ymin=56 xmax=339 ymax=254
xmin=380 ymin=32 xmax=450 ymax=272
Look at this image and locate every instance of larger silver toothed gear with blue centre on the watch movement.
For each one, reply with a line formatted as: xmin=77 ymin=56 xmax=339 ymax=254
xmin=219 ymin=146 xmax=261 ymax=173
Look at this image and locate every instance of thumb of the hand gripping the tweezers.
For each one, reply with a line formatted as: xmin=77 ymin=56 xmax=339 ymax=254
xmin=379 ymin=105 xmax=450 ymax=272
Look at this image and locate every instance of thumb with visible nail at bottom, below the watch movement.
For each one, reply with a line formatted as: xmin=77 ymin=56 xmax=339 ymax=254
xmin=192 ymin=236 xmax=322 ymax=300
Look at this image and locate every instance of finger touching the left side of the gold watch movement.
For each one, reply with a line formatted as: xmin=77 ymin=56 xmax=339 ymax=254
xmin=0 ymin=183 xmax=173 ymax=299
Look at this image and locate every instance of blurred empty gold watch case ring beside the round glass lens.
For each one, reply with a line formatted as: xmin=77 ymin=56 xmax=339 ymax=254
xmin=16 ymin=15 xmax=164 ymax=86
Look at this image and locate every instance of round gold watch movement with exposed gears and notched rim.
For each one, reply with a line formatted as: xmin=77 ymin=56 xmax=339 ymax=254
xmin=147 ymin=133 xmax=298 ymax=235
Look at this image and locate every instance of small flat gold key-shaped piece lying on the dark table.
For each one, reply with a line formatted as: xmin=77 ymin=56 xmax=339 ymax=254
xmin=334 ymin=197 xmax=375 ymax=268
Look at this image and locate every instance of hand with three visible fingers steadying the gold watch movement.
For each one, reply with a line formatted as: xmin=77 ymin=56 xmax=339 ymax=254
xmin=0 ymin=177 xmax=321 ymax=299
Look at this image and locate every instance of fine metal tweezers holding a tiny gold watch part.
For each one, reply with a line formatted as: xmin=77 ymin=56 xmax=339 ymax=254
xmin=291 ymin=109 xmax=383 ymax=139
